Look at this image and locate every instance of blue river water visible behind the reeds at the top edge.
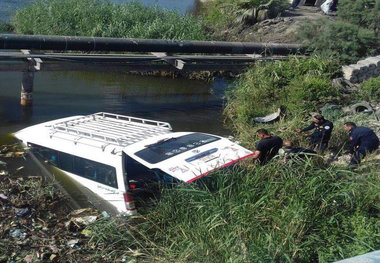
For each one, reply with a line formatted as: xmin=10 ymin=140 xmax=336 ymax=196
xmin=0 ymin=0 xmax=196 ymax=22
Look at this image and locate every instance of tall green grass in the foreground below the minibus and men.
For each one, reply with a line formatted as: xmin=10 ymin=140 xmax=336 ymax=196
xmin=86 ymin=161 xmax=380 ymax=263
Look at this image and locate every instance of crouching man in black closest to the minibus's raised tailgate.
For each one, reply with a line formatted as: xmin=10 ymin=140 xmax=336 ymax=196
xmin=253 ymin=129 xmax=282 ymax=165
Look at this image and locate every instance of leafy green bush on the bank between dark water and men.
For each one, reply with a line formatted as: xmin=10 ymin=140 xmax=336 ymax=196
xmin=225 ymin=57 xmax=338 ymax=126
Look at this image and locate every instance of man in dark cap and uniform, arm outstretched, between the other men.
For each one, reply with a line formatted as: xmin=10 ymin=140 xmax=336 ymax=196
xmin=296 ymin=114 xmax=334 ymax=151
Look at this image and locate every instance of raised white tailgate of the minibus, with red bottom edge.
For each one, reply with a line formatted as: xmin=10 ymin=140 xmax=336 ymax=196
xmin=124 ymin=133 xmax=253 ymax=186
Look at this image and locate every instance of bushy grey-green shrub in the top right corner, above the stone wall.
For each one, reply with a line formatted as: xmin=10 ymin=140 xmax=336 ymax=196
xmin=299 ymin=0 xmax=380 ymax=63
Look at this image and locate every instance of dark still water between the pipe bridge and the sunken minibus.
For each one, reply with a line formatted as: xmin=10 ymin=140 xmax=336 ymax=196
xmin=0 ymin=72 xmax=228 ymax=135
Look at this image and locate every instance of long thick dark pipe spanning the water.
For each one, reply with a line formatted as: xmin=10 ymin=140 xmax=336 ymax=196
xmin=0 ymin=34 xmax=305 ymax=55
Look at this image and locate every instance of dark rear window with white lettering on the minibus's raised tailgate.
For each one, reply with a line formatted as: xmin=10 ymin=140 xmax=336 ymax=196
xmin=135 ymin=133 xmax=220 ymax=164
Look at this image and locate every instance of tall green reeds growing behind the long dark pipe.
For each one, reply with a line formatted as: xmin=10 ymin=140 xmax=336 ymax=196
xmin=12 ymin=0 xmax=206 ymax=40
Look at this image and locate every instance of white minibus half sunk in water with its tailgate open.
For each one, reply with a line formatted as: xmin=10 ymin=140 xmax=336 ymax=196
xmin=15 ymin=112 xmax=252 ymax=215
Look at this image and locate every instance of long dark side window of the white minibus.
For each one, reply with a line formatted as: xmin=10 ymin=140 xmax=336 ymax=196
xmin=29 ymin=143 xmax=117 ymax=188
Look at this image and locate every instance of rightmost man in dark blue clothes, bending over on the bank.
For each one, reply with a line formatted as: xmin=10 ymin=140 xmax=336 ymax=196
xmin=344 ymin=122 xmax=379 ymax=165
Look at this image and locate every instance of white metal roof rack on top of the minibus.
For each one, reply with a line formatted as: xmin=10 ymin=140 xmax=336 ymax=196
xmin=50 ymin=112 xmax=172 ymax=150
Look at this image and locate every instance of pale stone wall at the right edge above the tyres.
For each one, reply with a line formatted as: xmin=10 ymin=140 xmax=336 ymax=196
xmin=342 ymin=56 xmax=380 ymax=83
